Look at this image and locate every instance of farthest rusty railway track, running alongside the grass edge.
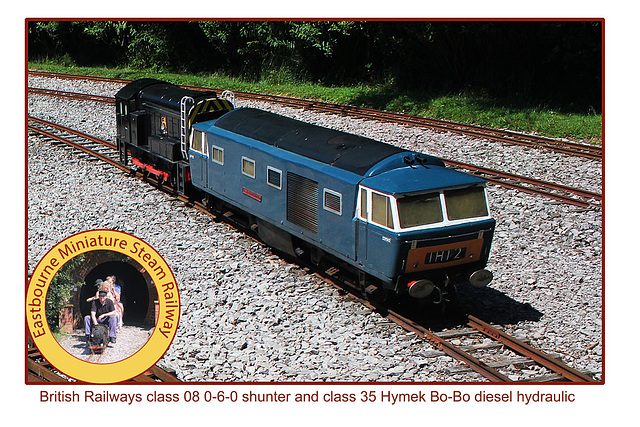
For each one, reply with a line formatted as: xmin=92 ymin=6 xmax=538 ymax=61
xmin=29 ymin=71 xmax=602 ymax=159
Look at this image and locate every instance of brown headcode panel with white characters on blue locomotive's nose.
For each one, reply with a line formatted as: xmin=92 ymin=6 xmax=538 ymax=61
xmin=405 ymin=239 xmax=484 ymax=273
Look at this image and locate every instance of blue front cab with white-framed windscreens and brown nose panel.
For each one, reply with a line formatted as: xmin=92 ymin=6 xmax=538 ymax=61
xmin=355 ymin=155 xmax=495 ymax=298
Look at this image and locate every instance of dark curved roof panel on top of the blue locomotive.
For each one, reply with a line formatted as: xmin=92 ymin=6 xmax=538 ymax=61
xmin=215 ymin=108 xmax=407 ymax=176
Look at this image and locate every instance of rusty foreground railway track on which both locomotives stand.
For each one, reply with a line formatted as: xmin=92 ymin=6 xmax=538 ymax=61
xmin=28 ymin=118 xmax=594 ymax=382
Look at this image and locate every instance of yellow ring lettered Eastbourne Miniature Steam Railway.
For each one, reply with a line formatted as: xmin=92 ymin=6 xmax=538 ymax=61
xmin=25 ymin=230 xmax=180 ymax=384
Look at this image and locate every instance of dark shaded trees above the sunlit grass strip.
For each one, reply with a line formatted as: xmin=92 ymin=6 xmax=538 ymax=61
xmin=28 ymin=20 xmax=602 ymax=112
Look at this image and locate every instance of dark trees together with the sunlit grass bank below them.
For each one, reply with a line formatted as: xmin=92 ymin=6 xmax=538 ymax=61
xmin=28 ymin=20 xmax=602 ymax=139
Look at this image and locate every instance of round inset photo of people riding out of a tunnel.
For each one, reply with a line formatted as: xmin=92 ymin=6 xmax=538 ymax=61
xmin=46 ymin=250 xmax=157 ymax=363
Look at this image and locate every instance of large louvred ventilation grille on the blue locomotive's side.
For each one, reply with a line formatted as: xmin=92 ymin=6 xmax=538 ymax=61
xmin=287 ymin=172 xmax=318 ymax=233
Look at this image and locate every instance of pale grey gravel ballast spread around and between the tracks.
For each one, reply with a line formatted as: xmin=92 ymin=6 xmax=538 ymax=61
xmin=28 ymin=77 xmax=602 ymax=382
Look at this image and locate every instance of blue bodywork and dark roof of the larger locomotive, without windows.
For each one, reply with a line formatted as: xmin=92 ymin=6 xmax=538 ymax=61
xmin=189 ymin=108 xmax=495 ymax=288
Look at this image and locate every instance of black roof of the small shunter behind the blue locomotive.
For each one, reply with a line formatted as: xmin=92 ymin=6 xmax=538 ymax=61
xmin=116 ymin=78 xmax=217 ymax=110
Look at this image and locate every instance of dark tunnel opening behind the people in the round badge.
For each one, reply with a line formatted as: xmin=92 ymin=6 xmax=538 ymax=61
xmin=78 ymin=261 xmax=155 ymax=326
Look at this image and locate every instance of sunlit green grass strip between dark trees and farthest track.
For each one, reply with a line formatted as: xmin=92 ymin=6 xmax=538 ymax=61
xmin=29 ymin=62 xmax=602 ymax=143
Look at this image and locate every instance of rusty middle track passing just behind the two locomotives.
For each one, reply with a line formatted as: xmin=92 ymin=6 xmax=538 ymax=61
xmin=28 ymin=88 xmax=602 ymax=208
